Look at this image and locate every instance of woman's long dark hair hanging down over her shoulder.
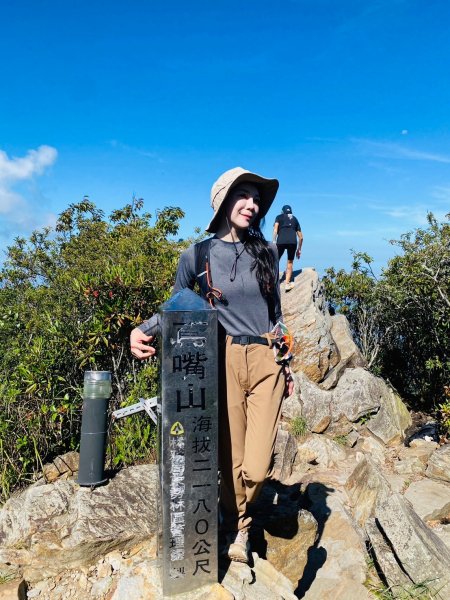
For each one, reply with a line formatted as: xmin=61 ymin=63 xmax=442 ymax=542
xmin=245 ymin=218 xmax=278 ymax=298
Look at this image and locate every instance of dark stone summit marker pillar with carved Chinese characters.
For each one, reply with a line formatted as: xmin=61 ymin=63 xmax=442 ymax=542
xmin=159 ymin=289 xmax=218 ymax=596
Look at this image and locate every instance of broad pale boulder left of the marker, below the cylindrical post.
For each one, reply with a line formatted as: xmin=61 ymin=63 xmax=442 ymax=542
xmin=0 ymin=465 xmax=158 ymax=581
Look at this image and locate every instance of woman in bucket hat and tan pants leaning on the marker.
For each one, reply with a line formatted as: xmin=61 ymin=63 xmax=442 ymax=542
xmin=131 ymin=167 xmax=293 ymax=562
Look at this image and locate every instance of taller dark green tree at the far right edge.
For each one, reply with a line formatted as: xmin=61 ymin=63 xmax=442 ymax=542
xmin=379 ymin=213 xmax=450 ymax=406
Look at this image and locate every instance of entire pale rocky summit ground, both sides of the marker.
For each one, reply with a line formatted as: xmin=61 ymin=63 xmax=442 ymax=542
xmin=0 ymin=269 xmax=450 ymax=600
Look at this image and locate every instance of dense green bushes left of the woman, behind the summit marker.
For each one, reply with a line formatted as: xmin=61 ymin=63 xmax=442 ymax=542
xmin=0 ymin=198 xmax=195 ymax=498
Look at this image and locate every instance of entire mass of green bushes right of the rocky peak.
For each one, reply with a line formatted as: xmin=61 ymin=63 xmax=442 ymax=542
xmin=324 ymin=213 xmax=450 ymax=408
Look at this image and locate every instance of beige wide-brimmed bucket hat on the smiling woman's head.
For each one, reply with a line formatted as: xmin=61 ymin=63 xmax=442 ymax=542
xmin=206 ymin=167 xmax=279 ymax=233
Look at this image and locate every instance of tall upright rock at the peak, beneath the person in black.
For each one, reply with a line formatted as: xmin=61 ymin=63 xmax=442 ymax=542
xmin=282 ymin=269 xmax=340 ymax=382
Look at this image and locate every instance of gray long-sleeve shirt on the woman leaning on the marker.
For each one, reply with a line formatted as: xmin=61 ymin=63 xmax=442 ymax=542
xmin=139 ymin=238 xmax=282 ymax=336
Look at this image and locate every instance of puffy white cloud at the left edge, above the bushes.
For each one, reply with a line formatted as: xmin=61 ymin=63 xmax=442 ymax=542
xmin=0 ymin=146 xmax=58 ymax=237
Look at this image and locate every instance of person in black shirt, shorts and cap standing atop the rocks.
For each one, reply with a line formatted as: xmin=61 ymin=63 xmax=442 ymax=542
xmin=272 ymin=204 xmax=303 ymax=292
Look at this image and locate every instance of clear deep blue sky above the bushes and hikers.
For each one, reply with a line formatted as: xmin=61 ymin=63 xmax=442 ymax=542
xmin=0 ymin=0 xmax=450 ymax=272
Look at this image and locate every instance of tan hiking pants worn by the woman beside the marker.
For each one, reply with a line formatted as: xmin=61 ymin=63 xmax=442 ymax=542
xmin=219 ymin=336 xmax=285 ymax=531
